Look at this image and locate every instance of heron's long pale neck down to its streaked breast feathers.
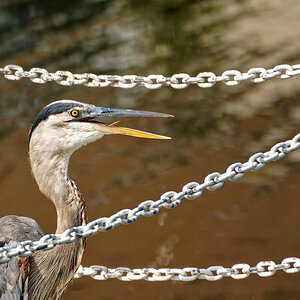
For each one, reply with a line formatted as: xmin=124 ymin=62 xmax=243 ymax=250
xmin=29 ymin=148 xmax=87 ymax=299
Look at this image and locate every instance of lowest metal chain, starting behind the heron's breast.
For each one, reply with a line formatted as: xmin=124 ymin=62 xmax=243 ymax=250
xmin=74 ymin=257 xmax=300 ymax=281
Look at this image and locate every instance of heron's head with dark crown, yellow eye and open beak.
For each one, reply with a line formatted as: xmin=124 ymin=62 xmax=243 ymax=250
xmin=29 ymin=100 xmax=173 ymax=154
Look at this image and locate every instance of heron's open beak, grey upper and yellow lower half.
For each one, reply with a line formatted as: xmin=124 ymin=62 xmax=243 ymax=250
xmin=87 ymin=107 xmax=174 ymax=139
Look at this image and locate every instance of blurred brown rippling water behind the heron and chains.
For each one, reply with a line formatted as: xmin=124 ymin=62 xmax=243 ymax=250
xmin=0 ymin=0 xmax=300 ymax=300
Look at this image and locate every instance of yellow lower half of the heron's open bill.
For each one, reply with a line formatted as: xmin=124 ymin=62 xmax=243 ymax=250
xmin=94 ymin=123 xmax=171 ymax=140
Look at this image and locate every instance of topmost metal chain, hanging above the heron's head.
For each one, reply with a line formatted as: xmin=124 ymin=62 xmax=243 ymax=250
xmin=0 ymin=64 xmax=300 ymax=89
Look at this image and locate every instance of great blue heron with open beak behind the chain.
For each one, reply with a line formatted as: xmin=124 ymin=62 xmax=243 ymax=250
xmin=0 ymin=100 xmax=171 ymax=300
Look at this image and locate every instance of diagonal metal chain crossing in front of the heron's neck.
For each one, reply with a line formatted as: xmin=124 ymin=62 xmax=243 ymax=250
xmin=0 ymin=133 xmax=300 ymax=264
